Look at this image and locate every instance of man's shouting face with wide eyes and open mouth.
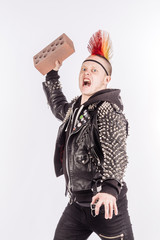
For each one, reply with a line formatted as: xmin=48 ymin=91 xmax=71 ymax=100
xmin=79 ymin=55 xmax=110 ymax=97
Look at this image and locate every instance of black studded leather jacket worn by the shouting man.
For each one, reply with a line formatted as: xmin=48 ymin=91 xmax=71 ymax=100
xmin=42 ymin=70 xmax=128 ymax=201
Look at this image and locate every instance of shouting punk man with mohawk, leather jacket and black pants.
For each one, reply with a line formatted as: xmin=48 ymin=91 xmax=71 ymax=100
xmin=43 ymin=30 xmax=134 ymax=240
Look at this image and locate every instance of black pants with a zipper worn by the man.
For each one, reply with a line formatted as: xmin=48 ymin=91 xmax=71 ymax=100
xmin=54 ymin=191 xmax=134 ymax=240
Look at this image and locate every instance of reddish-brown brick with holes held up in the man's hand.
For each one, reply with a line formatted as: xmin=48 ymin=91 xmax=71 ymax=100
xmin=33 ymin=33 xmax=75 ymax=75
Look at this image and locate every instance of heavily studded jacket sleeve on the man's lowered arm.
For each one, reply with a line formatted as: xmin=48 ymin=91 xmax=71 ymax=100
xmin=97 ymin=101 xmax=128 ymax=199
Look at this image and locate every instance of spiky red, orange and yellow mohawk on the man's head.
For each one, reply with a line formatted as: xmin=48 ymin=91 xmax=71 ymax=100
xmin=87 ymin=30 xmax=112 ymax=61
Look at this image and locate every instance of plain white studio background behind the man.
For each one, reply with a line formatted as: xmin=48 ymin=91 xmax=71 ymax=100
xmin=0 ymin=0 xmax=160 ymax=240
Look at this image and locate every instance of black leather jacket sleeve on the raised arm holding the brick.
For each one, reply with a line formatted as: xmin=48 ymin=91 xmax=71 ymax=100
xmin=42 ymin=70 xmax=71 ymax=121
